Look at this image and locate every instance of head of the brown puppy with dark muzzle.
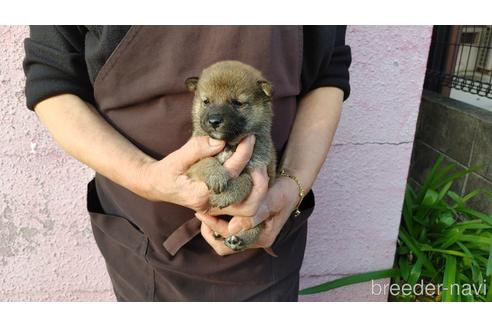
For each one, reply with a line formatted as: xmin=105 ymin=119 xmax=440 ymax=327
xmin=186 ymin=61 xmax=272 ymax=144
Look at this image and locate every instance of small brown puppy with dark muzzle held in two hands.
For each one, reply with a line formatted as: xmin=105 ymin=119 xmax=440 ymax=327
xmin=185 ymin=61 xmax=276 ymax=251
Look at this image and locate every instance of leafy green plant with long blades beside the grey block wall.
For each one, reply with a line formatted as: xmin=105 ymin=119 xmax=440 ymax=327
xmin=300 ymin=157 xmax=492 ymax=301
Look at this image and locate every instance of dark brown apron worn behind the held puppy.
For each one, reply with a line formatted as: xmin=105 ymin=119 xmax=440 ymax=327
xmin=88 ymin=26 xmax=314 ymax=301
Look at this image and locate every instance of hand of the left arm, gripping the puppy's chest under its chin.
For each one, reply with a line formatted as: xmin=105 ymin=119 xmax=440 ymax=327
xmin=139 ymin=136 xmax=255 ymax=211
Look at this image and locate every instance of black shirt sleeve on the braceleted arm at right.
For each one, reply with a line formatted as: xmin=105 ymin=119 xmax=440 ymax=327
xmin=301 ymin=26 xmax=352 ymax=100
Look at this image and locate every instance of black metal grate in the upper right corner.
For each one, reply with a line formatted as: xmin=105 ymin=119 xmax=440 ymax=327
xmin=424 ymin=25 xmax=492 ymax=99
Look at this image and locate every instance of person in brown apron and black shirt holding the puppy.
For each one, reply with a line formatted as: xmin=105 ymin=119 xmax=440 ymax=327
xmin=24 ymin=26 xmax=351 ymax=301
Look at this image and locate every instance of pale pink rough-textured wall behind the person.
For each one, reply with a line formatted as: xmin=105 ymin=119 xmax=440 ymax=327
xmin=0 ymin=26 xmax=431 ymax=301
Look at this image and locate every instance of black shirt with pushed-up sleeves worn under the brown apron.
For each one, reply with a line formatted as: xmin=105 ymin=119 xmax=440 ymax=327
xmin=23 ymin=25 xmax=351 ymax=109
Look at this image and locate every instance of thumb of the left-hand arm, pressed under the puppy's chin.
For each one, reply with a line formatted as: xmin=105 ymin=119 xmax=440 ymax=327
xmin=176 ymin=136 xmax=225 ymax=169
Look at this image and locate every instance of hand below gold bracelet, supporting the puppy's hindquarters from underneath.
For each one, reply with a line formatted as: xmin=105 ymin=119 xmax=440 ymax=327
xmin=195 ymin=177 xmax=298 ymax=256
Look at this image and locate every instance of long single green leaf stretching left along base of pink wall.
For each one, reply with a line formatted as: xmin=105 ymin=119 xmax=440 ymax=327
xmin=299 ymin=269 xmax=399 ymax=295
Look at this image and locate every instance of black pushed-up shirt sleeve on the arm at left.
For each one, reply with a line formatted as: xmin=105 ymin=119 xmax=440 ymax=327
xmin=23 ymin=26 xmax=94 ymax=110
